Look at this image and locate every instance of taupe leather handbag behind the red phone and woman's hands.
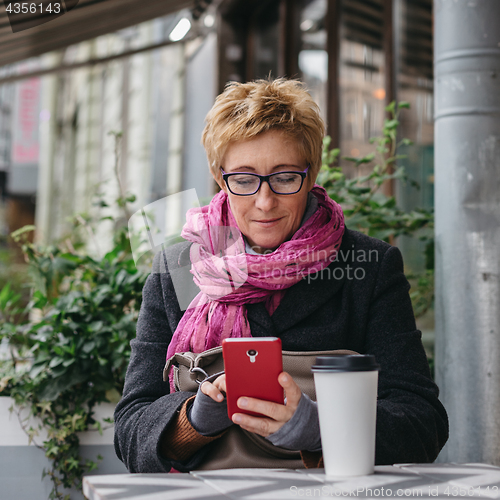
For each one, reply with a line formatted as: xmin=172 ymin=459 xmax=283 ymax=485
xmin=163 ymin=346 xmax=358 ymax=470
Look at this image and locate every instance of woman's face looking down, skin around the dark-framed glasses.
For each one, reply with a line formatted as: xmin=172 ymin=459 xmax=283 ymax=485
xmin=216 ymin=130 xmax=312 ymax=253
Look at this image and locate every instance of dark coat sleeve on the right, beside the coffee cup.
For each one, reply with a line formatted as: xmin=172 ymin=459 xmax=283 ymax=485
xmin=366 ymin=247 xmax=448 ymax=465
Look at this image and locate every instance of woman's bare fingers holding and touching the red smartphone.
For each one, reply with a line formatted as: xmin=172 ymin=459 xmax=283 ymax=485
xmin=230 ymin=372 xmax=302 ymax=437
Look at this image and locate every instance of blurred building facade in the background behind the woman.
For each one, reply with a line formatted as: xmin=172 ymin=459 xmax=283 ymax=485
xmin=0 ymin=0 xmax=433 ymax=268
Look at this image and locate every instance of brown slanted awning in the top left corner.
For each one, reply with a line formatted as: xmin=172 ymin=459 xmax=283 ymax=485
xmin=0 ymin=0 xmax=197 ymax=66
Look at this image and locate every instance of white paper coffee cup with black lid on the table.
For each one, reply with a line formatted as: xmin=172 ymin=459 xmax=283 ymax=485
xmin=312 ymin=354 xmax=380 ymax=476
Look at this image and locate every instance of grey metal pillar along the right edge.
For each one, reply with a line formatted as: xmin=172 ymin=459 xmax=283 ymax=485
xmin=434 ymin=0 xmax=500 ymax=465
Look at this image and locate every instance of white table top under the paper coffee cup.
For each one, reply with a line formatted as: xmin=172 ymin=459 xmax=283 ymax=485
xmin=83 ymin=464 xmax=500 ymax=500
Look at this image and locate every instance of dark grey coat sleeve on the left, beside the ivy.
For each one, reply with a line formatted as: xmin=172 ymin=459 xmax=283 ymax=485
xmin=114 ymin=253 xmax=213 ymax=472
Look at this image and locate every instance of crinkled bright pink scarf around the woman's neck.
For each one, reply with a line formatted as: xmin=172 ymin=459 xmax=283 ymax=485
xmin=167 ymin=185 xmax=344 ymax=390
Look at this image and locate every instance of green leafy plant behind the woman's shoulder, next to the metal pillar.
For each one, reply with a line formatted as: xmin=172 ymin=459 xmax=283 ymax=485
xmin=316 ymin=102 xmax=434 ymax=317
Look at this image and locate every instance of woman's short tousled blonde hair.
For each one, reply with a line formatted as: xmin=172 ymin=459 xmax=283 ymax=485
xmin=202 ymin=78 xmax=325 ymax=187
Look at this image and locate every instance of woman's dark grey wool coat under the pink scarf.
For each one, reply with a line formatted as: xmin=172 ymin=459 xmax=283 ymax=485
xmin=115 ymin=228 xmax=448 ymax=472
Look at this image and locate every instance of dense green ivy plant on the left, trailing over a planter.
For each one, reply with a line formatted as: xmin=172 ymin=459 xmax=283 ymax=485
xmin=0 ymin=135 xmax=148 ymax=500
